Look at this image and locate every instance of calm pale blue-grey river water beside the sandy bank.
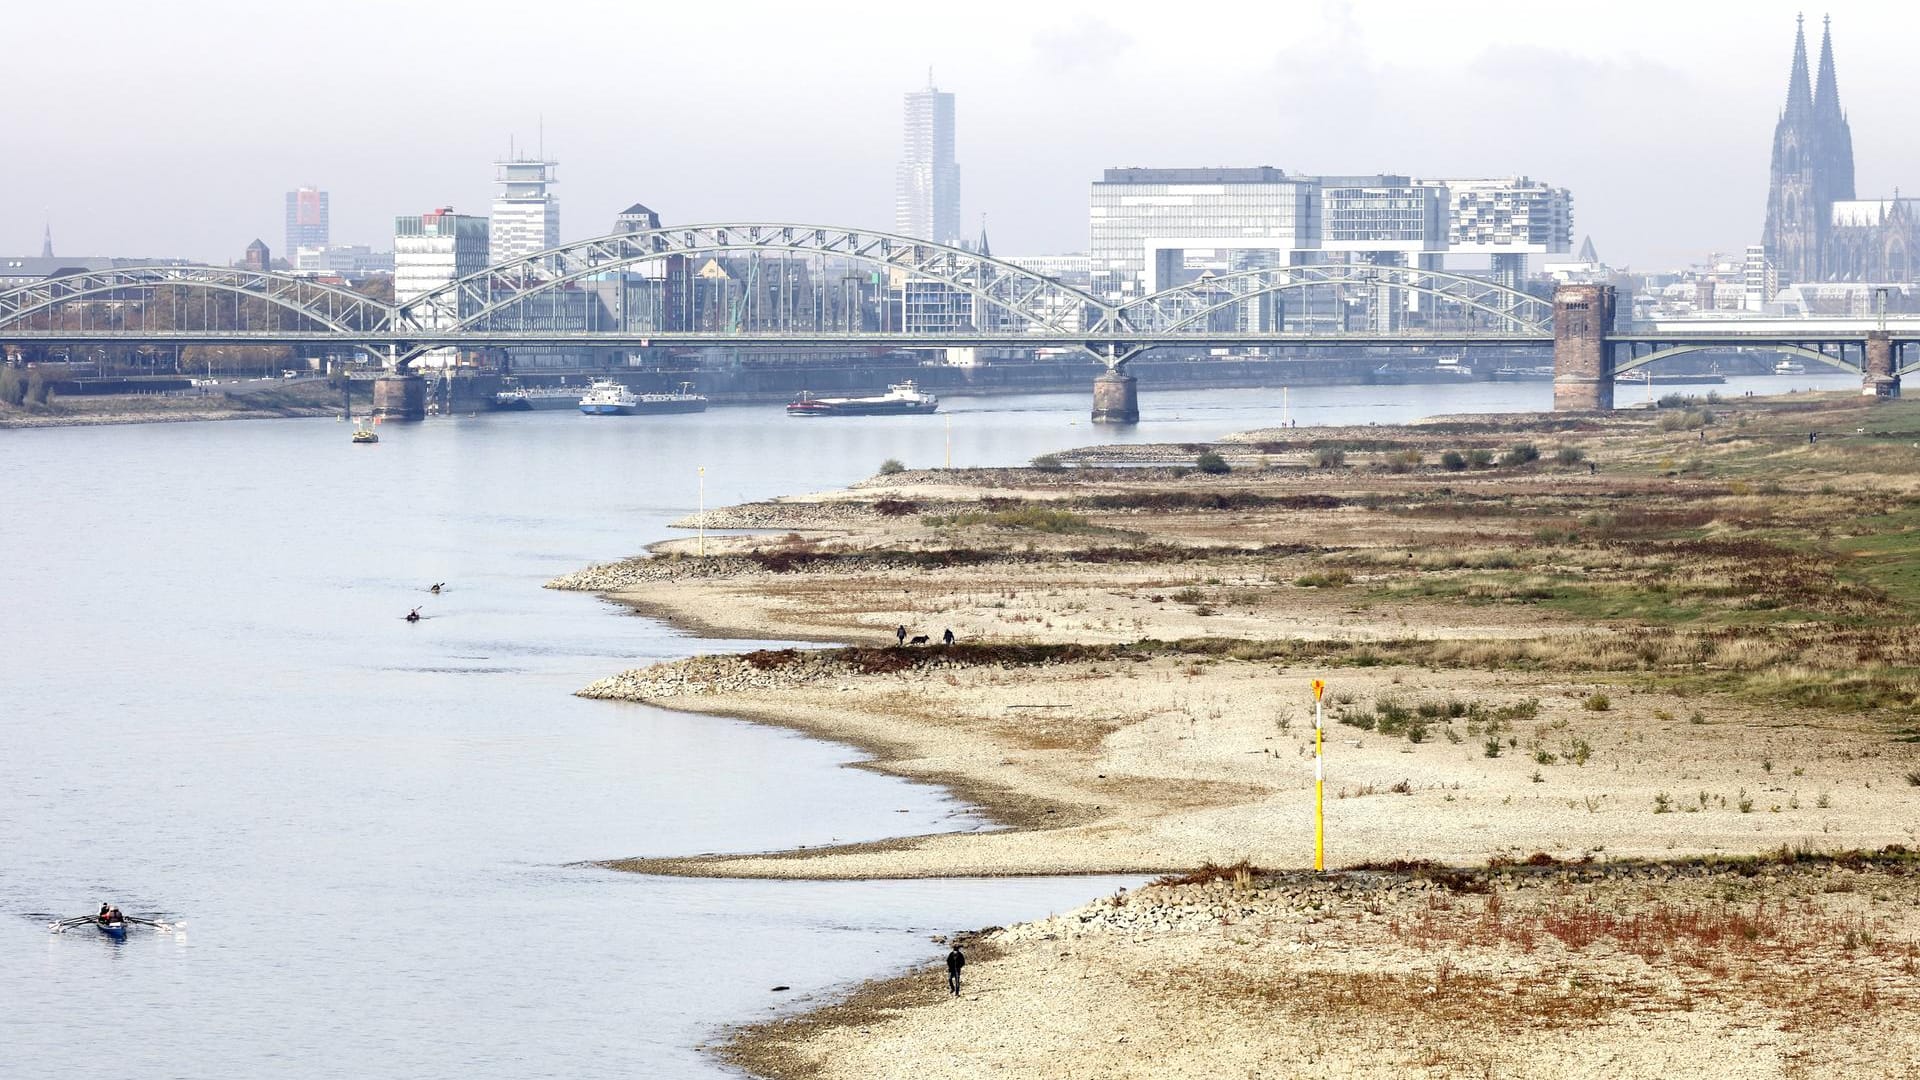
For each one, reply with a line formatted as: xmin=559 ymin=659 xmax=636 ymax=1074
xmin=0 ymin=375 xmax=1847 ymax=1078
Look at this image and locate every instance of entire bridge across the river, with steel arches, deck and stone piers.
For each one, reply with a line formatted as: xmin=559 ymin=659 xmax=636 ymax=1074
xmin=0 ymin=223 xmax=1920 ymax=423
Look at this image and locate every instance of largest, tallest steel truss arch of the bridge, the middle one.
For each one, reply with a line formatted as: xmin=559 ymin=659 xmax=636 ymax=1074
xmin=396 ymin=223 xmax=1112 ymax=334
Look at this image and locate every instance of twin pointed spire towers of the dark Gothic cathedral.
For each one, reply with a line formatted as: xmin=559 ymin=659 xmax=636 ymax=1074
xmin=1763 ymin=19 xmax=1853 ymax=282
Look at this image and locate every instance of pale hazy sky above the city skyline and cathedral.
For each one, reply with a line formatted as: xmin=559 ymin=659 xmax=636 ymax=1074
xmin=0 ymin=0 xmax=1920 ymax=267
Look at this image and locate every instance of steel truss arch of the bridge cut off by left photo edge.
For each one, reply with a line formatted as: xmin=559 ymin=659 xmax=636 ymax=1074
xmin=0 ymin=265 xmax=394 ymax=334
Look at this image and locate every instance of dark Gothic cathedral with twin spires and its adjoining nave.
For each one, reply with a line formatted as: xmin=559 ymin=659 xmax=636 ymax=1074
xmin=1763 ymin=21 xmax=1920 ymax=284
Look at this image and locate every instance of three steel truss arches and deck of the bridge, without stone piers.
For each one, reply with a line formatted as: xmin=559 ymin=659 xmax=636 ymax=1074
xmin=0 ymin=223 xmax=1551 ymax=369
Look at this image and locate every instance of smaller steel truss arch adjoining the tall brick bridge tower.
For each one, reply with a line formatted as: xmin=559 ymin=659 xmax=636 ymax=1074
xmin=1119 ymin=263 xmax=1553 ymax=334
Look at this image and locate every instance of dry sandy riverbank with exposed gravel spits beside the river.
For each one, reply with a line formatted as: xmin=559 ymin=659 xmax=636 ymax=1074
xmin=555 ymin=398 xmax=1920 ymax=1076
